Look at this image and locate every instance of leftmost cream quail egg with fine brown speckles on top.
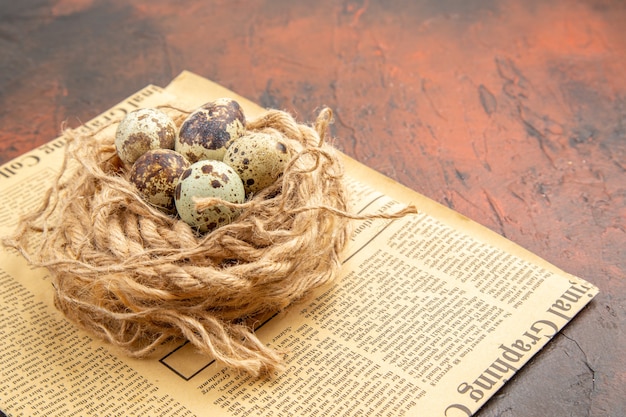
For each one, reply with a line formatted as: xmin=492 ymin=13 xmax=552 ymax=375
xmin=115 ymin=108 xmax=177 ymax=167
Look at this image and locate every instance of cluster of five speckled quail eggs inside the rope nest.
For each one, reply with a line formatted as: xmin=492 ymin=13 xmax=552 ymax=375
xmin=115 ymin=98 xmax=289 ymax=232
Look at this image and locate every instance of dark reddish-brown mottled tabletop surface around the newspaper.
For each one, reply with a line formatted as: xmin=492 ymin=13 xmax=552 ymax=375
xmin=0 ymin=0 xmax=626 ymax=417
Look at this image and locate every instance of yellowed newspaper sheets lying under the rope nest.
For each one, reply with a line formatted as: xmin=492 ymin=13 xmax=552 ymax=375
xmin=0 ymin=72 xmax=598 ymax=417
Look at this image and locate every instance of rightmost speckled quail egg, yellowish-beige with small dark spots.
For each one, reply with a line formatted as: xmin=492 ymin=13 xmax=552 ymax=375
xmin=224 ymin=132 xmax=290 ymax=194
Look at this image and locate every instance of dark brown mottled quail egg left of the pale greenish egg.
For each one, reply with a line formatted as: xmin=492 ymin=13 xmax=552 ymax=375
xmin=129 ymin=149 xmax=189 ymax=214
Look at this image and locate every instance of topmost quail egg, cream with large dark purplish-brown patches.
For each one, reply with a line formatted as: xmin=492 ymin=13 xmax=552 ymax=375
xmin=175 ymin=98 xmax=246 ymax=163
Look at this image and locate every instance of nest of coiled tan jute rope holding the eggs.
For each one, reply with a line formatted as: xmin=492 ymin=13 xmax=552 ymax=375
xmin=4 ymin=108 xmax=414 ymax=376
